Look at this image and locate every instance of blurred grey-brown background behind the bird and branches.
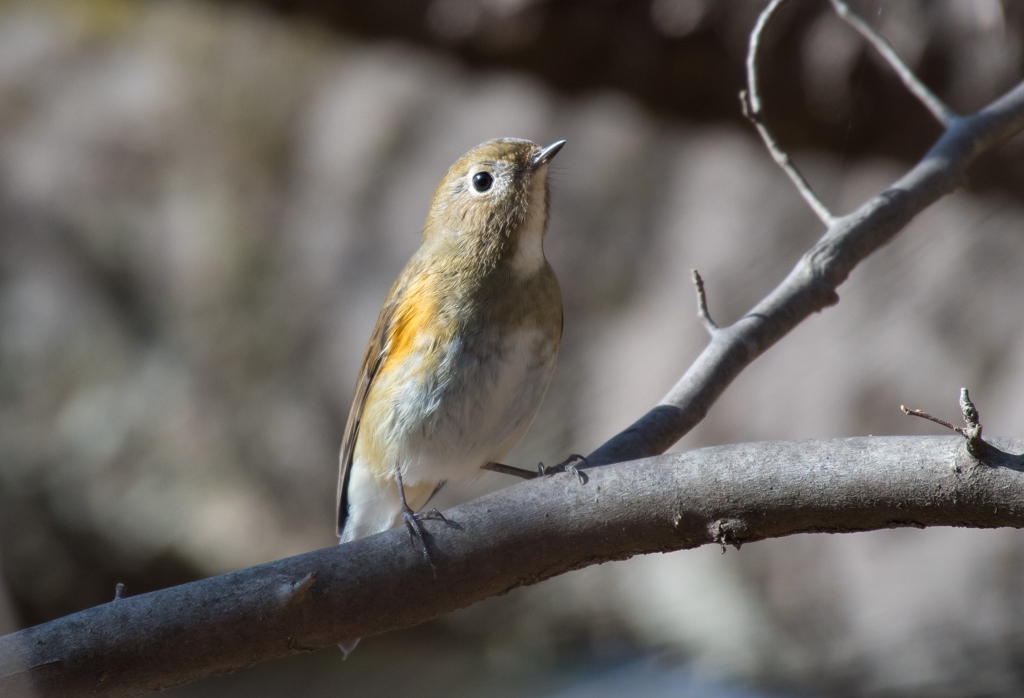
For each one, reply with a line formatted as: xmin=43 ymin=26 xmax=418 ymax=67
xmin=0 ymin=0 xmax=1024 ymax=698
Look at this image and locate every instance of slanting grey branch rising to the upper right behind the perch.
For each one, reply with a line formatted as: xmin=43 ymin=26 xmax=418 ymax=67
xmin=587 ymin=76 xmax=1024 ymax=466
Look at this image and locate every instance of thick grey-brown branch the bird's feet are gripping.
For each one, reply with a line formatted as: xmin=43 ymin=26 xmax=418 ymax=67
xmin=0 ymin=436 xmax=1024 ymax=696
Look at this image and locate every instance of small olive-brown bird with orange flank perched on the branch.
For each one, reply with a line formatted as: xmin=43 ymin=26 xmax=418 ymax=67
xmin=338 ymin=138 xmax=565 ymax=552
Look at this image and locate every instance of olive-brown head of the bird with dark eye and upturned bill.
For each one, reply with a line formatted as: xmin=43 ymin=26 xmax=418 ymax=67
xmin=423 ymin=138 xmax=565 ymax=271
